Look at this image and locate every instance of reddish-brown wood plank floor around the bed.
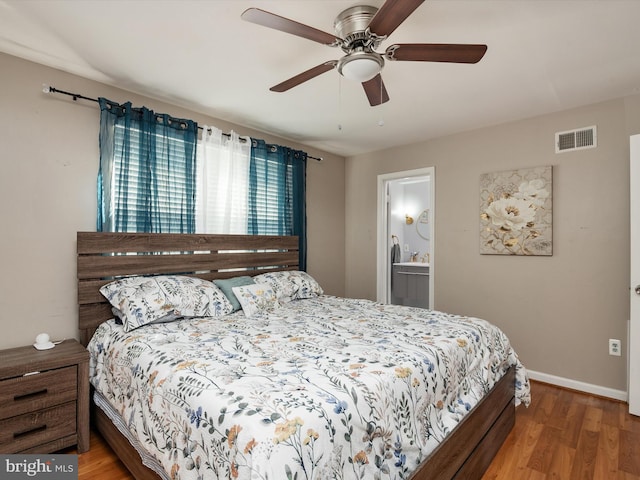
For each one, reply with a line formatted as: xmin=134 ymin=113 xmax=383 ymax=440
xmin=65 ymin=382 xmax=640 ymax=480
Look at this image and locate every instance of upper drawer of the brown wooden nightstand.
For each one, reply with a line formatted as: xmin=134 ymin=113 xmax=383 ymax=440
xmin=0 ymin=365 xmax=78 ymax=420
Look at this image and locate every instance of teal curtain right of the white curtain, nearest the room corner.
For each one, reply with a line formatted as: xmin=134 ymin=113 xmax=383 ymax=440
xmin=248 ymin=139 xmax=307 ymax=270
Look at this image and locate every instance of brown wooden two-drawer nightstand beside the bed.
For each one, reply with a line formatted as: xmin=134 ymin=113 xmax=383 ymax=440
xmin=0 ymin=340 xmax=89 ymax=453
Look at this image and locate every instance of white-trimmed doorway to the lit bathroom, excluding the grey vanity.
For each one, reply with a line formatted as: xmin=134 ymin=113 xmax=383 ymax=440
xmin=376 ymin=167 xmax=435 ymax=308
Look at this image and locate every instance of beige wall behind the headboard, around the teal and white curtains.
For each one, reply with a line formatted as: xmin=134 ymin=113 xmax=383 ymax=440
xmin=0 ymin=54 xmax=345 ymax=348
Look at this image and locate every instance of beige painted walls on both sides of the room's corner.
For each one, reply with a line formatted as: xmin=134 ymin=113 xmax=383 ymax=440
xmin=5 ymin=49 xmax=640 ymax=398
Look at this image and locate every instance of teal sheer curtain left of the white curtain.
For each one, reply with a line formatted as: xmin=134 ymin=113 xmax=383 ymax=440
xmin=97 ymin=98 xmax=198 ymax=233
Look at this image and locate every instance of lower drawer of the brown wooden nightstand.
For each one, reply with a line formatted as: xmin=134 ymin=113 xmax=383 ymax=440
xmin=0 ymin=402 xmax=76 ymax=453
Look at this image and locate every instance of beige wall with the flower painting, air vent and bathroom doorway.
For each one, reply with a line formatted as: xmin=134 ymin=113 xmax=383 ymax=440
xmin=346 ymin=96 xmax=640 ymax=392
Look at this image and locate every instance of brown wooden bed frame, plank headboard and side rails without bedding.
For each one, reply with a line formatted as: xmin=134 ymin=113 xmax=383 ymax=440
xmin=77 ymin=232 xmax=515 ymax=480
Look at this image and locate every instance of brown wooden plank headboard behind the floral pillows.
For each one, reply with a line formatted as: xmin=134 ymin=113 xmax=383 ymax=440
xmin=77 ymin=232 xmax=299 ymax=346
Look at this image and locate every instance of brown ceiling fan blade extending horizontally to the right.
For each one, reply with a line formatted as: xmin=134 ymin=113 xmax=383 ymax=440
xmin=385 ymin=43 xmax=487 ymax=63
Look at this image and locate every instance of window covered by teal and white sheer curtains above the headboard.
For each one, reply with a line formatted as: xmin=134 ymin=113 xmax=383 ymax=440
xmin=97 ymin=98 xmax=307 ymax=270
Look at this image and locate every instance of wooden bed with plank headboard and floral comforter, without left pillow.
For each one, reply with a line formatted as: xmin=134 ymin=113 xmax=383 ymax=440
xmin=77 ymin=232 xmax=529 ymax=480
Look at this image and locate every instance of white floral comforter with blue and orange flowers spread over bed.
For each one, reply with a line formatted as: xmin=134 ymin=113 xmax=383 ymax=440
xmin=89 ymin=296 xmax=529 ymax=480
